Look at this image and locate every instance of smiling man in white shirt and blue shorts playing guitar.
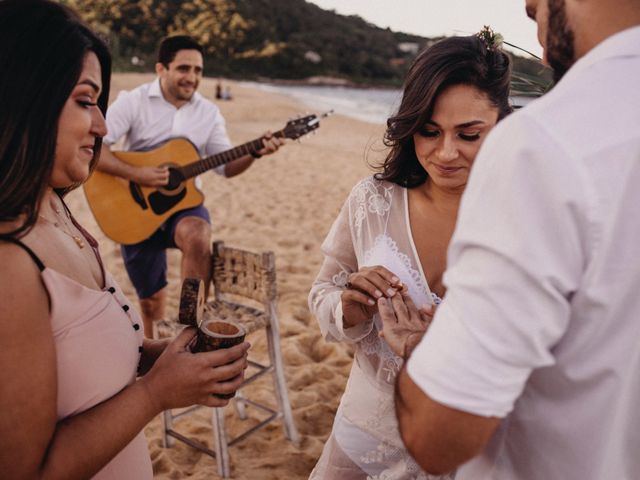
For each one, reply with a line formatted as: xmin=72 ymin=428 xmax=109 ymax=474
xmin=97 ymin=35 xmax=283 ymax=337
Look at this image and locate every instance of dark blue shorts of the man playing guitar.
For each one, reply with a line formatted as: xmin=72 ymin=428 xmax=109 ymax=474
xmin=120 ymin=205 xmax=211 ymax=298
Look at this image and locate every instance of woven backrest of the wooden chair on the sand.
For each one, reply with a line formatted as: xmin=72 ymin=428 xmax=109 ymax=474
xmin=212 ymin=241 xmax=277 ymax=311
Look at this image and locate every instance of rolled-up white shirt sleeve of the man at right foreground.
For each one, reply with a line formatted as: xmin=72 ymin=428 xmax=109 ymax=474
xmin=407 ymin=111 xmax=593 ymax=417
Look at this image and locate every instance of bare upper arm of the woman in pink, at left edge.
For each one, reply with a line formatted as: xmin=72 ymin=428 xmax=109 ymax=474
xmin=0 ymin=248 xmax=57 ymax=479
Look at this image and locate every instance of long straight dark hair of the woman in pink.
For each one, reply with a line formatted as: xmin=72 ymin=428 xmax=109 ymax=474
xmin=0 ymin=0 xmax=111 ymax=237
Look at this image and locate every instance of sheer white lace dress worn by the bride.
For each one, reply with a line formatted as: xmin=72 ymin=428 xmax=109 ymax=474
xmin=309 ymin=177 xmax=453 ymax=480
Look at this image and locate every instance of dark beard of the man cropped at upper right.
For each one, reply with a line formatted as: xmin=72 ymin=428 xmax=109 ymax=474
xmin=547 ymin=0 xmax=576 ymax=83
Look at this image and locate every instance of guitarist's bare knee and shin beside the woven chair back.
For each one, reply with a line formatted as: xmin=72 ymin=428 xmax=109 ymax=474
xmin=174 ymin=217 xmax=211 ymax=298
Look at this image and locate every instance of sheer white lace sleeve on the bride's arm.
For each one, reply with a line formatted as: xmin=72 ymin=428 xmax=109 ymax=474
xmin=309 ymin=182 xmax=373 ymax=342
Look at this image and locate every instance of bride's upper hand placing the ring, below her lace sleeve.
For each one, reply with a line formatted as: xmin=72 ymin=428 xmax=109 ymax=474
xmin=340 ymin=265 xmax=405 ymax=328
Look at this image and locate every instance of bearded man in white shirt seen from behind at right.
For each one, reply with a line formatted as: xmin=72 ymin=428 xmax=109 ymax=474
xmin=379 ymin=0 xmax=640 ymax=480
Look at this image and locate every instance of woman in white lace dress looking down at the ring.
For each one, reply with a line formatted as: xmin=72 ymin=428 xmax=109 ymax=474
xmin=309 ymin=29 xmax=511 ymax=480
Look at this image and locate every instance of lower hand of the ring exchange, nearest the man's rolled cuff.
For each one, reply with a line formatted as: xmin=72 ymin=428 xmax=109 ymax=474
xmin=378 ymin=292 xmax=436 ymax=360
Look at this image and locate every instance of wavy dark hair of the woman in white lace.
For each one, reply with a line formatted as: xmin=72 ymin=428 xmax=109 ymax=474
xmin=375 ymin=35 xmax=511 ymax=188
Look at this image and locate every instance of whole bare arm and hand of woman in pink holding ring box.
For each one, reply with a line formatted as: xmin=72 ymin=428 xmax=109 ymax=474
xmin=0 ymin=248 xmax=248 ymax=479
